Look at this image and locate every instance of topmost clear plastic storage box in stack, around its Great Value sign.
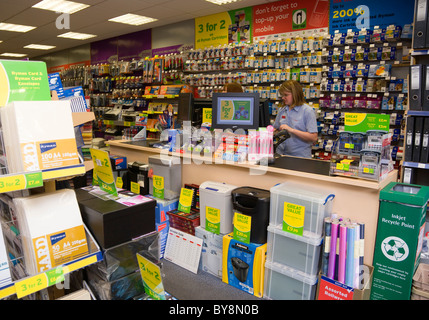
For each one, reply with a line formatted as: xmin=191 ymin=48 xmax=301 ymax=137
xmin=270 ymin=182 xmax=335 ymax=237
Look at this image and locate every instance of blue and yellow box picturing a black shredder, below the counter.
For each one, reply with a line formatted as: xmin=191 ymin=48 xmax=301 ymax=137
xmin=222 ymin=233 xmax=267 ymax=297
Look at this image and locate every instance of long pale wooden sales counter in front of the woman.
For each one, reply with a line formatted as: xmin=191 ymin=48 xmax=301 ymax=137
xmin=108 ymin=140 xmax=398 ymax=265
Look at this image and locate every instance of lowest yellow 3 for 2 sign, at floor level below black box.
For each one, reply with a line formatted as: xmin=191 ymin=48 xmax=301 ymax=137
xmin=137 ymin=253 xmax=165 ymax=300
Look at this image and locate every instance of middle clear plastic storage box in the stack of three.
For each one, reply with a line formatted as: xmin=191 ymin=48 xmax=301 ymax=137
xmin=267 ymin=226 xmax=323 ymax=276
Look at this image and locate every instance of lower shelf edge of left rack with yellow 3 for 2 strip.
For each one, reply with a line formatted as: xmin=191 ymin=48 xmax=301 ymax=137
xmin=0 ymin=222 xmax=103 ymax=299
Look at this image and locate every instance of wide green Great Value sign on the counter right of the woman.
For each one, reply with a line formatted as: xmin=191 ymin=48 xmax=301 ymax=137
xmin=344 ymin=112 xmax=390 ymax=132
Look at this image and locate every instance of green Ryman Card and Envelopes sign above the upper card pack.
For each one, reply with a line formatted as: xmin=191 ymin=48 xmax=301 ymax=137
xmin=0 ymin=60 xmax=51 ymax=107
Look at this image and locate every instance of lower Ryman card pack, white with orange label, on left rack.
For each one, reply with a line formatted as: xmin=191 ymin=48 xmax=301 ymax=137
xmin=13 ymin=189 xmax=88 ymax=275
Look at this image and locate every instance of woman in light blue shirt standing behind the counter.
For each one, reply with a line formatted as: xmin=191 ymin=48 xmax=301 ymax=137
xmin=273 ymin=80 xmax=317 ymax=158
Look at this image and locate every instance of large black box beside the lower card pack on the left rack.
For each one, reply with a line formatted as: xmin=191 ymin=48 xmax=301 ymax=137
xmin=76 ymin=189 xmax=156 ymax=249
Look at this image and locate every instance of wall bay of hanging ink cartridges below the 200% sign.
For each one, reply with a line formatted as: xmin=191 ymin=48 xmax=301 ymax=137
xmin=314 ymin=26 xmax=411 ymax=165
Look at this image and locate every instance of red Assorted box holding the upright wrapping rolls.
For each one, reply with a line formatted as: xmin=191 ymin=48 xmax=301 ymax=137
xmin=316 ymin=265 xmax=374 ymax=300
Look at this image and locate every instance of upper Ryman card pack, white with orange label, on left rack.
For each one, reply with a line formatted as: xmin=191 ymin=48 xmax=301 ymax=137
xmin=0 ymin=101 xmax=80 ymax=173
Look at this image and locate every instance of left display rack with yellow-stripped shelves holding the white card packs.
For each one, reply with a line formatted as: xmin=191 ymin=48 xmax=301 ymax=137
xmin=0 ymin=105 xmax=103 ymax=299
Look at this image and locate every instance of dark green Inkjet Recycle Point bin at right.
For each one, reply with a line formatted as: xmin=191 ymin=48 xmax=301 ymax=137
xmin=371 ymin=182 xmax=429 ymax=300
